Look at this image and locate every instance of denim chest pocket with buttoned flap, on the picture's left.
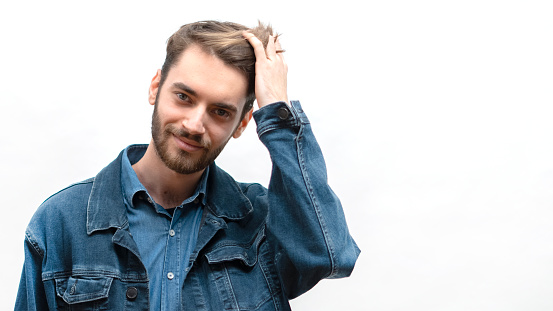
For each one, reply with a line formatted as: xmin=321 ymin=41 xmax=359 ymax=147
xmin=55 ymin=276 xmax=113 ymax=310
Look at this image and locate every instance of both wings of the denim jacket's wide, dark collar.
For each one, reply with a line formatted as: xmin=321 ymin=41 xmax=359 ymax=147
xmin=86 ymin=151 xmax=253 ymax=235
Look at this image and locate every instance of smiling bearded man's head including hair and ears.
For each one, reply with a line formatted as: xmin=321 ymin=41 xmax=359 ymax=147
xmin=149 ymin=22 xmax=271 ymax=174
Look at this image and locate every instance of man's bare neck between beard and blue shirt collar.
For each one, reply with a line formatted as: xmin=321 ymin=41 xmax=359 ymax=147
xmin=132 ymin=143 xmax=205 ymax=209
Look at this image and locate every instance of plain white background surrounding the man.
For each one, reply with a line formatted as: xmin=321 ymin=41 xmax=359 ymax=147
xmin=0 ymin=0 xmax=553 ymax=311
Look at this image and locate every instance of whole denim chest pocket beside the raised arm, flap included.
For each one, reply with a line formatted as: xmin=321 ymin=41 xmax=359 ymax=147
xmin=205 ymin=231 xmax=275 ymax=310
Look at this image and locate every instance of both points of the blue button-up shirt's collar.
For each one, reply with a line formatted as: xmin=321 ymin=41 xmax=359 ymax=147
xmin=121 ymin=145 xmax=209 ymax=207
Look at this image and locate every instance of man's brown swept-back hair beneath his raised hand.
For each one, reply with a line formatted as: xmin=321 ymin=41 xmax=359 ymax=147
xmin=160 ymin=21 xmax=273 ymax=117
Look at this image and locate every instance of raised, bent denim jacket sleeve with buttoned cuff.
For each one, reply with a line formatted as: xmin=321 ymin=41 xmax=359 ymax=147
xmin=254 ymin=101 xmax=360 ymax=299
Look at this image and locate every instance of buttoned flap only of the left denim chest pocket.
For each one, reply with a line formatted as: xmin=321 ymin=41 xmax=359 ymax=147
xmin=56 ymin=276 xmax=113 ymax=304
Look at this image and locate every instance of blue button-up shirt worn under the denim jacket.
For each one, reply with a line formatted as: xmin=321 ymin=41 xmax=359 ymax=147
xmin=121 ymin=145 xmax=209 ymax=310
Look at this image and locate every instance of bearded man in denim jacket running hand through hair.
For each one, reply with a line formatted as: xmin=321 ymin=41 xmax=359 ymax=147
xmin=16 ymin=21 xmax=359 ymax=310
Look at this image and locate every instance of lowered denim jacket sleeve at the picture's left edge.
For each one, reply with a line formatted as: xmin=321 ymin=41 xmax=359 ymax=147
xmin=15 ymin=230 xmax=48 ymax=311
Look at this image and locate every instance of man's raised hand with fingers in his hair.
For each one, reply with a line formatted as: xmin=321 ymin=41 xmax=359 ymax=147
xmin=244 ymin=32 xmax=288 ymax=108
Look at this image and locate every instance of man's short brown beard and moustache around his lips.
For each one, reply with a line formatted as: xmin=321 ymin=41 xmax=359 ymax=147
xmin=152 ymin=103 xmax=230 ymax=174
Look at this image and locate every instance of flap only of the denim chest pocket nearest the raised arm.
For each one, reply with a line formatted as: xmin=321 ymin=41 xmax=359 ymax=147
xmin=205 ymin=230 xmax=265 ymax=267
